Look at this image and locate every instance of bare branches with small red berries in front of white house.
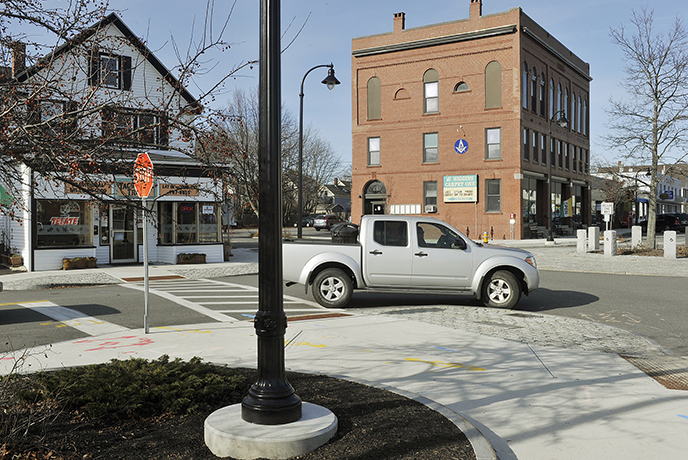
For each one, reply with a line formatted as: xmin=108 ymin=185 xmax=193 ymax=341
xmin=0 ymin=0 xmax=255 ymax=219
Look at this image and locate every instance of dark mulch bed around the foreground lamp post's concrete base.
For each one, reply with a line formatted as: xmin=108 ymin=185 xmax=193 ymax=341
xmin=0 ymin=369 xmax=476 ymax=460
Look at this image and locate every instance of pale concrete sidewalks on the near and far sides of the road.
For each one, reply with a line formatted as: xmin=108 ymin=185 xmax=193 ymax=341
xmin=0 ymin=239 xmax=688 ymax=460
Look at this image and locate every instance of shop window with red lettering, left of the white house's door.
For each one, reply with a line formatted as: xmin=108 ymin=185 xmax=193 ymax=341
xmin=36 ymin=200 xmax=93 ymax=248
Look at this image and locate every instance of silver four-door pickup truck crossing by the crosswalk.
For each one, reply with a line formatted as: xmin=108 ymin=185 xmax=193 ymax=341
xmin=282 ymin=215 xmax=540 ymax=308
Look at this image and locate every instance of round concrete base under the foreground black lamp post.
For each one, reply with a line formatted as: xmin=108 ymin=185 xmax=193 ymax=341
xmin=204 ymin=402 xmax=337 ymax=459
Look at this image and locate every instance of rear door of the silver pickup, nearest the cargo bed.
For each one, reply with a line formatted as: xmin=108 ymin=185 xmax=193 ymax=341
xmin=363 ymin=220 xmax=412 ymax=287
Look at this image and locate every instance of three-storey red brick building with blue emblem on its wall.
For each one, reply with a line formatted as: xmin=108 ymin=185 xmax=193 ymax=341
xmin=352 ymin=0 xmax=591 ymax=239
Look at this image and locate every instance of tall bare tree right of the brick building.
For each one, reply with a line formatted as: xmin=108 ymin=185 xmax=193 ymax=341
xmin=607 ymin=9 xmax=688 ymax=248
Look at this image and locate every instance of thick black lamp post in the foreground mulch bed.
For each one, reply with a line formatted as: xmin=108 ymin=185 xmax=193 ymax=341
xmin=241 ymin=0 xmax=301 ymax=425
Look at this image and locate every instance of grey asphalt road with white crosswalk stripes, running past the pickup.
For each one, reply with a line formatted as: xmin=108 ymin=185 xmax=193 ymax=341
xmin=0 ymin=271 xmax=688 ymax=356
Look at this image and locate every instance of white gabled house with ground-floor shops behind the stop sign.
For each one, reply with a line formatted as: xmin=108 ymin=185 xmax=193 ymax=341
xmin=0 ymin=14 xmax=223 ymax=271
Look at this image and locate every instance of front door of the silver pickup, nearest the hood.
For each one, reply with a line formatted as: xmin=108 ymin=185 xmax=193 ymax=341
xmin=411 ymin=222 xmax=473 ymax=289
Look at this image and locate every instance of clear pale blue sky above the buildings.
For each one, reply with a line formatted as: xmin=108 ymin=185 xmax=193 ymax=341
xmin=35 ymin=0 xmax=688 ymax=168
